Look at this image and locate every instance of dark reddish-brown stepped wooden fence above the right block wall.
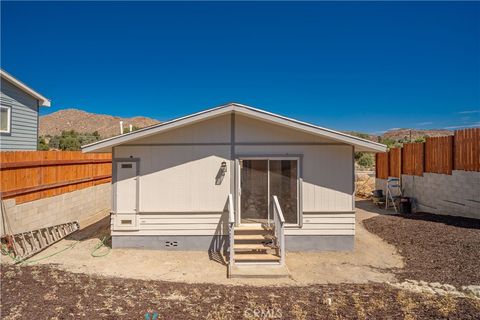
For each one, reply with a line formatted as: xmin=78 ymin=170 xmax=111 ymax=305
xmin=375 ymin=128 xmax=480 ymax=179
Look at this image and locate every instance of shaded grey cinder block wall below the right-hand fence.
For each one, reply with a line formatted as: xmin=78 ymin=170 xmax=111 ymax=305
xmin=375 ymin=170 xmax=480 ymax=219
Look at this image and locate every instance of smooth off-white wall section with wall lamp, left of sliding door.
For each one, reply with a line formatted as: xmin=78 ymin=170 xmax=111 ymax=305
xmin=115 ymin=145 xmax=231 ymax=212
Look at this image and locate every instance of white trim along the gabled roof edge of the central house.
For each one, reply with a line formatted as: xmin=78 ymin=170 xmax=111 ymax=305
xmin=82 ymin=103 xmax=387 ymax=153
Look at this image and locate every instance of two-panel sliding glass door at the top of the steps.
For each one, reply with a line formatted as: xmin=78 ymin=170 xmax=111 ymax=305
xmin=239 ymin=158 xmax=299 ymax=225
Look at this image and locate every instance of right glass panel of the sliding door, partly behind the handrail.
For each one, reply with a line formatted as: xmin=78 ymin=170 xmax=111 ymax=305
xmin=270 ymin=160 xmax=298 ymax=224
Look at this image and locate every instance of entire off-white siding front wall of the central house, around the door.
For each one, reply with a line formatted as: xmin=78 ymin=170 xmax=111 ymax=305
xmin=112 ymin=115 xmax=355 ymax=236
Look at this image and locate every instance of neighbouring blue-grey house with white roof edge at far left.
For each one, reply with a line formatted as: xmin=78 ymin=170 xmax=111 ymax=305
xmin=0 ymin=69 xmax=50 ymax=151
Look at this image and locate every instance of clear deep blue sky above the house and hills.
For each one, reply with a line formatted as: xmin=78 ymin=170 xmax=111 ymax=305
xmin=1 ymin=1 xmax=480 ymax=133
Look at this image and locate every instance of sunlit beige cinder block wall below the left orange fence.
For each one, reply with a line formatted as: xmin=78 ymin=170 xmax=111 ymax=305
xmin=0 ymin=183 xmax=111 ymax=234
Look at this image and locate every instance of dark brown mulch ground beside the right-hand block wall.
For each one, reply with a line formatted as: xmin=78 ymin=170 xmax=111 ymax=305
xmin=363 ymin=213 xmax=480 ymax=287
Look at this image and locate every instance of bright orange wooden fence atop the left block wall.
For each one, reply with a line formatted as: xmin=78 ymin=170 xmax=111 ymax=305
xmin=0 ymin=151 xmax=112 ymax=203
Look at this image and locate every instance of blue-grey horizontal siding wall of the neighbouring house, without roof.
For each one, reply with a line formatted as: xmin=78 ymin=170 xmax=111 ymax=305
xmin=0 ymin=79 xmax=38 ymax=151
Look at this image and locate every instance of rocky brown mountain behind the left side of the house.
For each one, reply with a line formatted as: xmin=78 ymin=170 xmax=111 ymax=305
xmin=39 ymin=109 xmax=160 ymax=139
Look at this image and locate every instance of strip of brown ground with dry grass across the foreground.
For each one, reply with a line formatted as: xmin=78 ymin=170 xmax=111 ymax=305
xmin=1 ymin=265 xmax=480 ymax=319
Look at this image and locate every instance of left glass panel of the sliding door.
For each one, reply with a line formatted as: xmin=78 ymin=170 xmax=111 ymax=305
xmin=240 ymin=160 xmax=269 ymax=223
